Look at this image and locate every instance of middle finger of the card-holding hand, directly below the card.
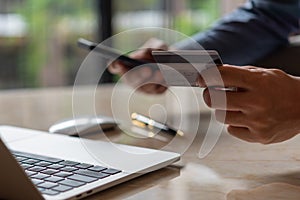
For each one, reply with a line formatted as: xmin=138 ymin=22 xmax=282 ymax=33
xmin=203 ymin=88 xmax=251 ymax=111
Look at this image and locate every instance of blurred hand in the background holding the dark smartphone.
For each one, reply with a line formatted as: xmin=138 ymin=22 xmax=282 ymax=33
xmin=108 ymin=38 xmax=168 ymax=94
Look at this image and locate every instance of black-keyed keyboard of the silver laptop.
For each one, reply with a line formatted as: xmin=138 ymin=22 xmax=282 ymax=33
xmin=12 ymin=151 xmax=121 ymax=195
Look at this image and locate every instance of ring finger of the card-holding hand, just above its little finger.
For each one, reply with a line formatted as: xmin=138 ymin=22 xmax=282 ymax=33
xmin=215 ymin=110 xmax=249 ymax=128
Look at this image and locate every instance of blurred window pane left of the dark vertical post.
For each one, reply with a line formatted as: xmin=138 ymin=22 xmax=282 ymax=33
xmin=0 ymin=0 xmax=96 ymax=88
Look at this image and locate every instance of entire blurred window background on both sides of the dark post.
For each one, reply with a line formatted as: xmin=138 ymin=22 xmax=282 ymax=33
xmin=0 ymin=0 xmax=241 ymax=89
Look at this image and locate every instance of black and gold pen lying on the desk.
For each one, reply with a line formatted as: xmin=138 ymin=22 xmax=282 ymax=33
xmin=131 ymin=112 xmax=184 ymax=136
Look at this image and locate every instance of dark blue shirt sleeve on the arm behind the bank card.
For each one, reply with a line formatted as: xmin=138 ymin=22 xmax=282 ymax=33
xmin=175 ymin=0 xmax=300 ymax=65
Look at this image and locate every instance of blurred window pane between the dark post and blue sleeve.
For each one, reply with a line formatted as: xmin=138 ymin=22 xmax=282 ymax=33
xmin=113 ymin=0 xmax=221 ymax=48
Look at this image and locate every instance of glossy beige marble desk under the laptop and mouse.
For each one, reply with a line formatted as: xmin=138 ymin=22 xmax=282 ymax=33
xmin=0 ymin=85 xmax=300 ymax=200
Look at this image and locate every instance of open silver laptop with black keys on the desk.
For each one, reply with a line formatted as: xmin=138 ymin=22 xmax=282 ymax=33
xmin=0 ymin=126 xmax=180 ymax=199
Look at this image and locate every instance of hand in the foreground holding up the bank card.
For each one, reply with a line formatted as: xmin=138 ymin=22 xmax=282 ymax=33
xmin=199 ymin=65 xmax=300 ymax=144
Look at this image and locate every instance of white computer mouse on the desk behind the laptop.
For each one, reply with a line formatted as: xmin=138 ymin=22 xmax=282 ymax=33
xmin=49 ymin=115 xmax=118 ymax=136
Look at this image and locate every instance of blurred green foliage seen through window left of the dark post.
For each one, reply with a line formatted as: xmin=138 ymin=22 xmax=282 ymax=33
xmin=17 ymin=0 xmax=94 ymax=87
